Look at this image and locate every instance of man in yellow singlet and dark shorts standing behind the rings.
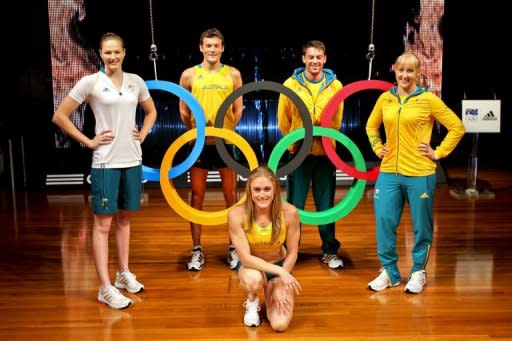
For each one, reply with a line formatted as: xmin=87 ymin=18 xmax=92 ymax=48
xmin=180 ymin=28 xmax=243 ymax=271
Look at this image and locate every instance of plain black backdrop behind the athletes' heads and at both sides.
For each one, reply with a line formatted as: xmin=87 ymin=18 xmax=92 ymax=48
xmin=8 ymin=0 xmax=512 ymax=189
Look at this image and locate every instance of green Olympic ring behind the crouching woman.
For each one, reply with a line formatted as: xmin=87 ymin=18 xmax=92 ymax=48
xmin=268 ymin=127 xmax=366 ymax=225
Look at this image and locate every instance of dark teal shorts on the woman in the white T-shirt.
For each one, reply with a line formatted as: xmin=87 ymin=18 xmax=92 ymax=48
xmin=91 ymin=165 xmax=142 ymax=215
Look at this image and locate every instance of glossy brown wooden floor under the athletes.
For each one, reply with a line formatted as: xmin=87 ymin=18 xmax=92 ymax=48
xmin=0 ymin=169 xmax=512 ymax=341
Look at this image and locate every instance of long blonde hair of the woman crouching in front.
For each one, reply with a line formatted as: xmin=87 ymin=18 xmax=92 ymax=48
xmin=242 ymin=166 xmax=283 ymax=242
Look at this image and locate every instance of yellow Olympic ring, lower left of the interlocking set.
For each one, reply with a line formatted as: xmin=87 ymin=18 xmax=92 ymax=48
xmin=160 ymin=127 xmax=258 ymax=225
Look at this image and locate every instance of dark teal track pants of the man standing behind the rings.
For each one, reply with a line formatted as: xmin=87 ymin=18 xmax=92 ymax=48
xmin=286 ymin=155 xmax=341 ymax=255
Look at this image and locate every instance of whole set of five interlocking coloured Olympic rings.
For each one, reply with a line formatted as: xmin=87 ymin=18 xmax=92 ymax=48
xmin=150 ymin=81 xmax=392 ymax=225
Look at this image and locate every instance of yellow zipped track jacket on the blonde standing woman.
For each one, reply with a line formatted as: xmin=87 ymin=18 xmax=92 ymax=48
xmin=366 ymin=87 xmax=464 ymax=176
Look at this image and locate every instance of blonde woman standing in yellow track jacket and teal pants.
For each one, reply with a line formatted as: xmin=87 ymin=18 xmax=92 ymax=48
xmin=366 ymin=53 xmax=464 ymax=293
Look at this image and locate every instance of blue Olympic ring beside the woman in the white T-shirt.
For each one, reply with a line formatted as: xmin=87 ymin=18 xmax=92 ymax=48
xmin=142 ymin=80 xmax=206 ymax=181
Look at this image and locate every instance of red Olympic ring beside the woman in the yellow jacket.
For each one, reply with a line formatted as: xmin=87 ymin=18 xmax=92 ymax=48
xmin=320 ymin=80 xmax=393 ymax=180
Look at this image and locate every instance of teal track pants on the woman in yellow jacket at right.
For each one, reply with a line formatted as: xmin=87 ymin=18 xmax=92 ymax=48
xmin=373 ymin=173 xmax=436 ymax=283
